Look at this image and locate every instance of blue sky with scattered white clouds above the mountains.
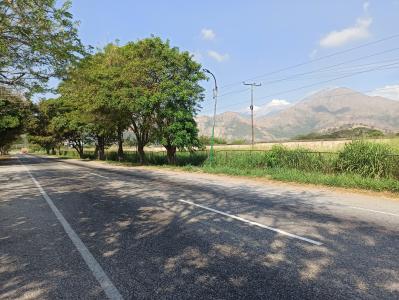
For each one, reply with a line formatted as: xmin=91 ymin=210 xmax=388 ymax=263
xmin=65 ymin=0 xmax=399 ymax=114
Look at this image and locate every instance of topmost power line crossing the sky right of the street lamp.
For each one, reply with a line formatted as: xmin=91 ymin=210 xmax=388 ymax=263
xmin=221 ymin=34 xmax=399 ymax=88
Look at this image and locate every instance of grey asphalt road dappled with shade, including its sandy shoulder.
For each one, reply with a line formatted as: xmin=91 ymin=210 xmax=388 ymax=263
xmin=0 ymin=156 xmax=399 ymax=300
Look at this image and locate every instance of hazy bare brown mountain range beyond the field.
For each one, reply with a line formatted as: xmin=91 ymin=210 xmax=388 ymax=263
xmin=197 ymin=88 xmax=399 ymax=141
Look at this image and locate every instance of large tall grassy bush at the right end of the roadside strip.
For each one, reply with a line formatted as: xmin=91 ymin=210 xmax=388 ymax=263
xmin=337 ymin=141 xmax=397 ymax=178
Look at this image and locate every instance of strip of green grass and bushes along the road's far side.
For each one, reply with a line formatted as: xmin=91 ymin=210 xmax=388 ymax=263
xmin=31 ymin=140 xmax=399 ymax=194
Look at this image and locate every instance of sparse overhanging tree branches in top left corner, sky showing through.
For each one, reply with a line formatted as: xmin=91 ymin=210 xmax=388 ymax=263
xmin=0 ymin=0 xmax=85 ymax=93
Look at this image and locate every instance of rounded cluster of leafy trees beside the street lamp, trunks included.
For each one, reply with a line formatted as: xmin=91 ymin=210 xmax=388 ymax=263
xmin=59 ymin=37 xmax=206 ymax=162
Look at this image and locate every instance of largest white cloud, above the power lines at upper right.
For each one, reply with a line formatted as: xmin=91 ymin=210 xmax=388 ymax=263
xmin=320 ymin=17 xmax=373 ymax=48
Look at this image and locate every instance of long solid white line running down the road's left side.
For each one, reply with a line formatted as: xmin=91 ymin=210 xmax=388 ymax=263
xmin=18 ymin=158 xmax=123 ymax=300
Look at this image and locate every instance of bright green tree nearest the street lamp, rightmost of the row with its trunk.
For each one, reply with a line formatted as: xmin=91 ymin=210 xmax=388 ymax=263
xmin=151 ymin=44 xmax=206 ymax=164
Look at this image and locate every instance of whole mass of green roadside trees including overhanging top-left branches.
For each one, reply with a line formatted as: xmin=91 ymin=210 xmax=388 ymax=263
xmin=0 ymin=0 xmax=206 ymax=163
